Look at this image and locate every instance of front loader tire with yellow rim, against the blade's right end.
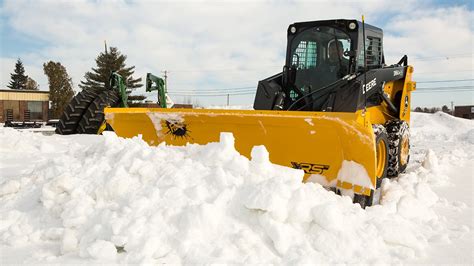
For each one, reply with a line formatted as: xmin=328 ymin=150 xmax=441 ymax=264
xmin=354 ymin=125 xmax=389 ymax=209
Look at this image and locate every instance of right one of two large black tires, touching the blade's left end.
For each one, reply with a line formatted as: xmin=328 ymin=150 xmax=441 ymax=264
xmin=77 ymin=90 xmax=120 ymax=134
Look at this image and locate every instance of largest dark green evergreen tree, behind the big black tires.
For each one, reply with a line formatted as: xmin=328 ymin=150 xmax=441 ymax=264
xmin=79 ymin=46 xmax=146 ymax=103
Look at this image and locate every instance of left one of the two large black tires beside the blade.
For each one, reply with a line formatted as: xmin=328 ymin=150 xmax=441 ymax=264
xmin=55 ymin=89 xmax=100 ymax=135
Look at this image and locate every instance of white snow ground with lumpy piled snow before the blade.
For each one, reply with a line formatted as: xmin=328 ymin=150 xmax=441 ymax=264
xmin=0 ymin=113 xmax=474 ymax=264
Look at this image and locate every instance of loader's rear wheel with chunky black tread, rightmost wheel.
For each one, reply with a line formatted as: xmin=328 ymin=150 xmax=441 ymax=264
xmin=386 ymin=120 xmax=410 ymax=178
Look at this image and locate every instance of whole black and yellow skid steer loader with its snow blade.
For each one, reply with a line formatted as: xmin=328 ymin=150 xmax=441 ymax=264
xmin=59 ymin=19 xmax=416 ymax=207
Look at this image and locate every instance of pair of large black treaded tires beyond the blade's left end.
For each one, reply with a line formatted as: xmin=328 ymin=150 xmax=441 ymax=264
xmin=56 ymin=89 xmax=120 ymax=135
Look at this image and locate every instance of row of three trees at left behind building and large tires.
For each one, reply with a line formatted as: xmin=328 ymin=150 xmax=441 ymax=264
xmin=7 ymin=46 xmax=146 ymax=118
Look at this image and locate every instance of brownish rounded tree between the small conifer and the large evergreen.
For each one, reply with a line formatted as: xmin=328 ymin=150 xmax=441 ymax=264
xmin=43 ymin=61 xmax=74 ymax=118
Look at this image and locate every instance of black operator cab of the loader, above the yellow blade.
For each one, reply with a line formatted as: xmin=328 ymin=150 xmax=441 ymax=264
xmin=254 ymin=19 xmax=384 ymax=111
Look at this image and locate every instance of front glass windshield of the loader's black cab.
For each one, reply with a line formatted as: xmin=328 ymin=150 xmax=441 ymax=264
xmin=290 ymin=26 xmax=351 ymax=101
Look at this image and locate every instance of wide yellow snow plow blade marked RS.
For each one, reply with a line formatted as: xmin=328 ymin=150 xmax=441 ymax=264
xmin=105 ymin=108 xmax=376 ymax=195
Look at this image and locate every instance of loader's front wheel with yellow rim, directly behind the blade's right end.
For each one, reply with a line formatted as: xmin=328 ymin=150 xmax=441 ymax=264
xmin=354 ymin=125 xmax=389 ymax=209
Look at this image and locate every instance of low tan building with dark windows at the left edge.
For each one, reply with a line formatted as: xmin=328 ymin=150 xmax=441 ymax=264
xmin=0 ymin=90 xmax=49 ymax=123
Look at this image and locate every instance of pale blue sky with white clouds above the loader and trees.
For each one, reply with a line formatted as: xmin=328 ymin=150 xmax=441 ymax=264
xmin=0 ymin=0 xmax=474 ymax=107
